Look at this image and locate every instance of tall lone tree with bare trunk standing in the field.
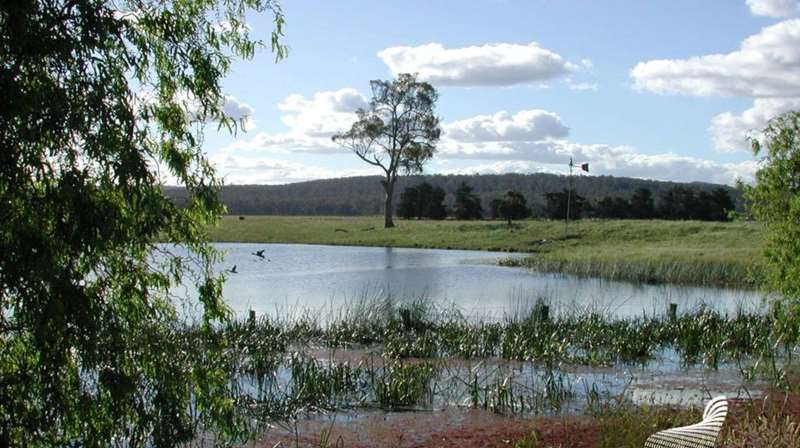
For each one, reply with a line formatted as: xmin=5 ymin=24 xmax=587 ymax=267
xmin=333 ymin=73 xmax=441 ymax=228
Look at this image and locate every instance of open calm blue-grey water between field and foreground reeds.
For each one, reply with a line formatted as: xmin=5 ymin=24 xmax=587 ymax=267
xmin=167 ymin=244 xmax=760 ymax=317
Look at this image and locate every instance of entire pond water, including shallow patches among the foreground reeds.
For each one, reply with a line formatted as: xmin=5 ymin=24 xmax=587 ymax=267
xmin=166 ymin=244 xmax=763 ymax=414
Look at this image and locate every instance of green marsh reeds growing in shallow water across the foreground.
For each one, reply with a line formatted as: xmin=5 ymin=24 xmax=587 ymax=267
xmin=184 ymin=296 xmax=796 ymax=430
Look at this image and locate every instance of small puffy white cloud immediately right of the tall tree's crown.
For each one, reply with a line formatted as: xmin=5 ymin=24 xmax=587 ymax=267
xmin=442 ymin=109 xmax=569 ymax=142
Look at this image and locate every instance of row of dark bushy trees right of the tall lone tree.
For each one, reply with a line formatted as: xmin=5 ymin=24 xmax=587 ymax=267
xmin=397 ymin=182 xmax=735 ymax=224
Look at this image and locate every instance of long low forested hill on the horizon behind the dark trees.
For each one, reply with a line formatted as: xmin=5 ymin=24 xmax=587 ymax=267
xmin=161 ymin=173 xmax=739 ymax=215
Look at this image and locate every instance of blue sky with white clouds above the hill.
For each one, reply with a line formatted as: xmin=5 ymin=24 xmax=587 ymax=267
xmin=204 ymin=0 xmax=800 ymax=184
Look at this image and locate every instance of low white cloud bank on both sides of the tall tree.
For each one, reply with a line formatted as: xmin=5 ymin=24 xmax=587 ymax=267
xmin=212 ymin=89 xmax=756 ymax=184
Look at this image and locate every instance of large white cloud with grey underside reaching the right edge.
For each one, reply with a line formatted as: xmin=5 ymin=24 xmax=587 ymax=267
xmin=631 ymin=19 xmax=800 ymax=97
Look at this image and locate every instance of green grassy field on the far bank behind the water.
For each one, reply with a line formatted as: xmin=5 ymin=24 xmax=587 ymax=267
xmin=210 ymin=216 xmax=763 ymax=287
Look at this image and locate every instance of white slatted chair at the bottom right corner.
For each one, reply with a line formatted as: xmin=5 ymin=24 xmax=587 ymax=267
xmin=644 ymin=396 xmax=728 ymax=448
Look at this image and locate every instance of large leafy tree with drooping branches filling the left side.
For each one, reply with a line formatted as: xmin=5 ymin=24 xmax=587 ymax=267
xmin=0 ymin=0 xmax=286 ymax=446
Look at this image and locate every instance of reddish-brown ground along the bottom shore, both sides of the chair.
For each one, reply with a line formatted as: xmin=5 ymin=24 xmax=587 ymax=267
xmin=255 ymin=374 xmax=800 ymax=448
